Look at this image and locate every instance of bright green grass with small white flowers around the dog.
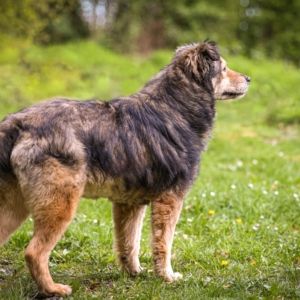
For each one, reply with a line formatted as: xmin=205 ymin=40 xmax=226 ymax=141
xmin=0 ymin=41 xmax=300 ymax=299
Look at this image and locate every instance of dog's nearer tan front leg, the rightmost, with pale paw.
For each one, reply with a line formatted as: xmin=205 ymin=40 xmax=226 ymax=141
xmin=151 ymin=193 xmax=183 ymax=282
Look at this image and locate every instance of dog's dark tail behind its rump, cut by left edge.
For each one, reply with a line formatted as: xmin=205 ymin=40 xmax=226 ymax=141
xmin=0 ymin=120 xmax=20 ymax=176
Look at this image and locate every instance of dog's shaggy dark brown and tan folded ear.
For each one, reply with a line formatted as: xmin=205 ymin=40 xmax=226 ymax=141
xmin=175 ymin=41 xmax=220 ymax=80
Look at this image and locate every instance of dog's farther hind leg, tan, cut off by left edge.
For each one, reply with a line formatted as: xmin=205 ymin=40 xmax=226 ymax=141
xmin=0 ymin=186 xmax=28 ymax=246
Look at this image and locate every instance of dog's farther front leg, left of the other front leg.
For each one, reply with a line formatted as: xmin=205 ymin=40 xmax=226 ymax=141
xmin=113 ymin=203 xmax=146 ymax=275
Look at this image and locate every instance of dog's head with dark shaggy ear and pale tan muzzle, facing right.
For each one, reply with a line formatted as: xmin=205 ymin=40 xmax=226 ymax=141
xmin=175 ymin=42 xmax=250 ymax=100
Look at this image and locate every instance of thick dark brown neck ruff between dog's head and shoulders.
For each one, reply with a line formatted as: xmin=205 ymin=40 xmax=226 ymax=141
xmin=137 ymin=66 xmax=215 ymax=137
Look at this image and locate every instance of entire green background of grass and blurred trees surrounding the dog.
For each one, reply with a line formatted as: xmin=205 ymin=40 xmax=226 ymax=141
xmin=0 ymin=0 xmax=300 ymax=299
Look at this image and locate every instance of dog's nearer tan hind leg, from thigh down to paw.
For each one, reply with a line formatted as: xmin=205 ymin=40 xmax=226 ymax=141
xmin=17 ymin=159 xmax=85 ymax=296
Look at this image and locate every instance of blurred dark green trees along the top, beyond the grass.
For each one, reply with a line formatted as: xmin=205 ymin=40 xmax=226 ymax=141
xmin=0 ymin=0 xmax=300 ymax=66
